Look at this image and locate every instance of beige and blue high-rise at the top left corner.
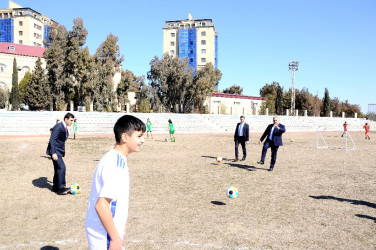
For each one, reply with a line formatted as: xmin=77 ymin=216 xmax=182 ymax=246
xmin=0 ymin=1 xmax=57 ymax=47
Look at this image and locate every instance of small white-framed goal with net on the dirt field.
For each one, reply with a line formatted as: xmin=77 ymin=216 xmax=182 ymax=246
xmin=316 ymin=130 xmax=356 ymax=151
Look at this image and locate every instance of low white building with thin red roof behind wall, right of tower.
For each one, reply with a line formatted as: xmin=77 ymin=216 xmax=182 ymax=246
xmin=204 ymin=93 xmax=265 ymax=115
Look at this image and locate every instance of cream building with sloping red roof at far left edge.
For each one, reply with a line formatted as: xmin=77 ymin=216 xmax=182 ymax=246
xmin=0 ymin=42 xmax=46 ymax=91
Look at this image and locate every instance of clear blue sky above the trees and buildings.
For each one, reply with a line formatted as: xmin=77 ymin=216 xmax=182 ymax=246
xmin=8 ymin=0 xmax=376 ymax=113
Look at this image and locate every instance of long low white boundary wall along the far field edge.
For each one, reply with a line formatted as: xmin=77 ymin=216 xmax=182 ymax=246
xmin=0 ymin=111 xmax=376 ymax=136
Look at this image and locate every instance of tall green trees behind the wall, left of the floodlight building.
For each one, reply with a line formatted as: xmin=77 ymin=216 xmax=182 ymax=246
xmin=0 ymin=18 xmax=222 ymax=113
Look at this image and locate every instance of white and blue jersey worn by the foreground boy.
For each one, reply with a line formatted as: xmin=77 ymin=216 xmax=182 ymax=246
xmin=86 ymin=149 xmax=129 ymax=249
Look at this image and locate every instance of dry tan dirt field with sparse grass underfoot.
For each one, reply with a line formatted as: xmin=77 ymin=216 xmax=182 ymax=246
xmin=0 ymin=133 xmax=376 ymax=249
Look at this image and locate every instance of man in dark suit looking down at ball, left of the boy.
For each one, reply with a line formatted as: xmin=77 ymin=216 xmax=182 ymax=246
xmin=46 ymin=113 xmax=74 ymax=194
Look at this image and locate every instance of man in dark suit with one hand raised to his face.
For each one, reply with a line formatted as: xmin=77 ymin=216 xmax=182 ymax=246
xmin=257 ymin=117 xmax=286 ymax=171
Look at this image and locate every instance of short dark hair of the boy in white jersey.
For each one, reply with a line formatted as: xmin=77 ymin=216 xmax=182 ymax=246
xmin=114 ymin=115 xmax=146 ymax=143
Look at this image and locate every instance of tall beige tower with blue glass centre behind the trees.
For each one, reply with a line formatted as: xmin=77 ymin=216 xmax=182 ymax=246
xmin=163 ymin=13 xmax=218 ymax=70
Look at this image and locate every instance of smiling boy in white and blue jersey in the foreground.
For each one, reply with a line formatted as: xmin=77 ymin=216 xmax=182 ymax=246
xmin=86 ymin=115 xmax=146 ymax=250
